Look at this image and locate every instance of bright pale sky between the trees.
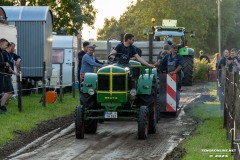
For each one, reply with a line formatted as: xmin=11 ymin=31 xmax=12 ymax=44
xmin=82 ymin=0 xmax=137 ymax=40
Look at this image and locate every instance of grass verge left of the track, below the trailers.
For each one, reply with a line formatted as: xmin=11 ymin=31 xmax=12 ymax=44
xmin=0 ymin=91 xmax=79 ymax=147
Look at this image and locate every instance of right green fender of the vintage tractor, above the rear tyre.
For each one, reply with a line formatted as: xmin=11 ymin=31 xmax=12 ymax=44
xmin=137 ymin=74 xmax=154 ymax=95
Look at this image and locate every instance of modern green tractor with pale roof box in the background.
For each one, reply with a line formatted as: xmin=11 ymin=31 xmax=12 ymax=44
xmin=152 ymin=18 xmax=194 ymax=86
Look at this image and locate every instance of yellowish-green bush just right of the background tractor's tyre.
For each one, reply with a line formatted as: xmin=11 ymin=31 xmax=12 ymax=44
xmin=193 ymin=61 xmax=210 ymax=82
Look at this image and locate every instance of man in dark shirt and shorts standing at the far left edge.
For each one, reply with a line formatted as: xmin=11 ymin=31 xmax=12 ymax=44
xmin=1 ymin=41 xmax=19 ymax=113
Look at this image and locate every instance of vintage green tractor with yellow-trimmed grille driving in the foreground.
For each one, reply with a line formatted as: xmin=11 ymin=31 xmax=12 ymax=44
xmin=75 ymin=56 xmax=159 ymax=139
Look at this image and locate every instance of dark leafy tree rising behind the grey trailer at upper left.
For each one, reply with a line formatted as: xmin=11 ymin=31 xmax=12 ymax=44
xmin=1 ymin=0 xmax=96 ymax=35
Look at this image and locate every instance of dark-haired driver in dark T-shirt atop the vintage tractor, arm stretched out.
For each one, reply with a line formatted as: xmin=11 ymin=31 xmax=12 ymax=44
xmin=109 ymin=33 xmax=153 ymax=67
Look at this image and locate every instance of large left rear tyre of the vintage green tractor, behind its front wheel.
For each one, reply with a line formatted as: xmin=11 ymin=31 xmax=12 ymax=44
xmin=80 ymin=93 xmax=98 ymax=134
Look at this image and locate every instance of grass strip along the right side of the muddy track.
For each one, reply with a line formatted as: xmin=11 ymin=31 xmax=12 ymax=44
xmin=181 ymin=83 xmax=233 ymax=160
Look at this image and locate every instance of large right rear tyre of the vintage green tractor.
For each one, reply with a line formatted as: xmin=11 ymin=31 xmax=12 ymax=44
xmin=138 ymin=94 xmax=157 ymax=134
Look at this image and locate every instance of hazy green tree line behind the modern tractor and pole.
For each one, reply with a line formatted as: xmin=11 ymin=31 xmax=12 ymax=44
xmin=97 ymin=0 xmax=240 ymax=55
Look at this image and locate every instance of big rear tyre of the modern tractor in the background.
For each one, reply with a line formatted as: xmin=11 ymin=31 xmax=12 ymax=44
xmin=182 ymin=56 xmax=193 ymax=86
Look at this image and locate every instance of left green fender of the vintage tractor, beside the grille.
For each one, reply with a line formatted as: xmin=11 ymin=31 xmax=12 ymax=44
xmin=81 ymin=73 xmax=97 ymax=93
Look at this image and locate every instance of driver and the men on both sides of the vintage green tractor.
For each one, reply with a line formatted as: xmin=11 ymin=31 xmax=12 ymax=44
xmin=78 ymin=33 xmax=183 ymax=105
